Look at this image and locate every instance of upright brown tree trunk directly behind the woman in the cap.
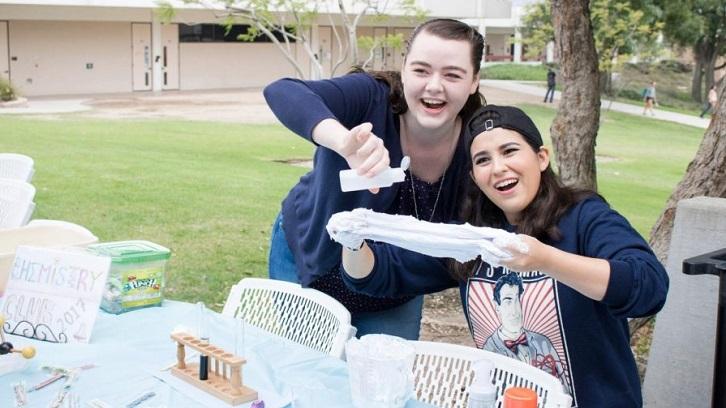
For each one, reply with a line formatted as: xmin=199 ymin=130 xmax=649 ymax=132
xmin=550 ymin=0 xmax=600 ymax=190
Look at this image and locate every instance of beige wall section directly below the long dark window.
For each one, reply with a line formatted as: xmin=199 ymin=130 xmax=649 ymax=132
xmin=179 ymin=42 xmax=298 ymax=89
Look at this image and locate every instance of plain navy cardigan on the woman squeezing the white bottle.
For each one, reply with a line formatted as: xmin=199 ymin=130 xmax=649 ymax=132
xmin=264 ymin=74 xmax=467 ymax=286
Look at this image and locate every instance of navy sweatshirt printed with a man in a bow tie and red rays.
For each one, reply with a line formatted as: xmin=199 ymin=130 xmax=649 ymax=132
xmin=343 ymin=197 xmax=668 ymax=408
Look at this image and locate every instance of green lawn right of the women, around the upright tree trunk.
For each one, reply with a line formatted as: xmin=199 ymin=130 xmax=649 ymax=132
xmin=522 ymin=105 xmax=704 ymax=234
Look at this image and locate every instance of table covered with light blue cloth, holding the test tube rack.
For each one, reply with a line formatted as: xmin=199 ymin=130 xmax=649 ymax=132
xmin=0 ymin=301 xmax=426 ymax=408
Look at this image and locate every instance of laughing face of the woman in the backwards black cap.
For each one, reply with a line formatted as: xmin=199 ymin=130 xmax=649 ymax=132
xmin=470 ymin=128 xmax=549 ymax=225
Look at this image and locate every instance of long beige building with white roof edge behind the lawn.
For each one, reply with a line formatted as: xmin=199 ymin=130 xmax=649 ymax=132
xmin=0 ymin=0 xmax=514 ymax=96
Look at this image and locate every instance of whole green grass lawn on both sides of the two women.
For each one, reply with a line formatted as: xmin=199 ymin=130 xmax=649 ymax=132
xmin=0 ymin=110 xmax=703 ymax=310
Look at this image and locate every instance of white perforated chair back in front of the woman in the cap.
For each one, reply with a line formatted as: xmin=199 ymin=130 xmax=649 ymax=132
xmin=411 ymin=341 xmax=572 ymax=408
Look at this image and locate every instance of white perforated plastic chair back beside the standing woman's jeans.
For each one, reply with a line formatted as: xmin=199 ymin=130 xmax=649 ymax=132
xmin=222 ymin=278 xmax=356 ymax=358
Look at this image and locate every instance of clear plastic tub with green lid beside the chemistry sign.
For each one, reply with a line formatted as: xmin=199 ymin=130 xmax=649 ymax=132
xmin=88 ymin=241 xmax=171 ymax=314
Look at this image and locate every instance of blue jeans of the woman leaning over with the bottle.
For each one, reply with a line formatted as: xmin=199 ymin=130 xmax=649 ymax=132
xmin=268 ymin=214 xmax=423 ymax=340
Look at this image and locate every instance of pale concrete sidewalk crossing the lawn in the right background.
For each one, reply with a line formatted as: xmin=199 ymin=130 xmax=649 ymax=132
xmin=481 ymin=79 xmax=709 ymax=129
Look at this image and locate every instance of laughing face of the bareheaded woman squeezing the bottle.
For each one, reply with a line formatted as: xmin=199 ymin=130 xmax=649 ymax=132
xmin=401 ymin=31 xmax=479 ymax=129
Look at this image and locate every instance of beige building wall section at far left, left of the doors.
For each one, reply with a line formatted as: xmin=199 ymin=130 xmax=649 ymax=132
xmin=9 ymin=21 xmax=131 ymax=96
